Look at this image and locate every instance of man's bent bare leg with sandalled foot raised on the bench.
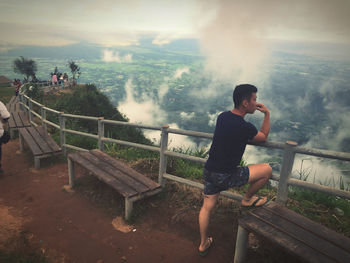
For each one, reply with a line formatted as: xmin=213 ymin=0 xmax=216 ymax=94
xmin=242 ymin=163 xmax=272 ymax=206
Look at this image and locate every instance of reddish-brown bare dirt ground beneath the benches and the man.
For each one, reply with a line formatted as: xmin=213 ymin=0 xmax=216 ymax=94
xmin=0 ymin=139 xmax=298 ymax=263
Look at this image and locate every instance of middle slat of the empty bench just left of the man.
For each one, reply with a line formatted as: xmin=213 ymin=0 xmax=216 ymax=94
xmin=80 ymin=152 xmax=152 ymax=193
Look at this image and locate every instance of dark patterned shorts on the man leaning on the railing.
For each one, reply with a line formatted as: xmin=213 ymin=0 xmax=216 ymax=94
xmin=203 ymin=166 xmax=249 ymax=195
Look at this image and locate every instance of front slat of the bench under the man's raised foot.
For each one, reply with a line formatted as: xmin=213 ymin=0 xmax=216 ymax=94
xmin=239 ymin=215 xmax=336 ymax=263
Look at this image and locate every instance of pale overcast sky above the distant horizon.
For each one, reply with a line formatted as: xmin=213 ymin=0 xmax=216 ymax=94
xmin=0 ymin=0 xmax=350 ymax=46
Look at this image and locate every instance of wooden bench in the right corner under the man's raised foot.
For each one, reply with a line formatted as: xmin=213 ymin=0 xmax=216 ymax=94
xmin=234 ymin=202 xmax=350 ymax=263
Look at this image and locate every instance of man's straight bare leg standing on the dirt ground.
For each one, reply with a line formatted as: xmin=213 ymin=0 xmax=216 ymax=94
xmin=198 ymin=194 xmax=219 ymax=251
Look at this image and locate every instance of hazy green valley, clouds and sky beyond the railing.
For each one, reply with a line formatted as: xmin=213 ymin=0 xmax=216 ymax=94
xmin=0 ymin=0 xmax=350 ymax=186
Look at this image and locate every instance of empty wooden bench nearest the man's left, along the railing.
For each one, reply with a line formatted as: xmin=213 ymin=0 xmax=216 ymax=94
xmin=68 ymin=150 xmax=161 ymax=219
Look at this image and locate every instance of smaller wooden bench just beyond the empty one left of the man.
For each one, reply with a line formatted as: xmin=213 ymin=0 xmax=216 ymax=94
xmin=18 ymin=126 xmax=62 ymax=169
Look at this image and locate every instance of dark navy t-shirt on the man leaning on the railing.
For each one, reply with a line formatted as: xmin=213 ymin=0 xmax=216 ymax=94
xmin=205 ymin=111 xmax=258 ymax=173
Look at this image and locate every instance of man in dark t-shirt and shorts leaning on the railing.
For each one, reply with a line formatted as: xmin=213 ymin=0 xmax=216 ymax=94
xmin=199 ymin=84 xmax=272 ymax=256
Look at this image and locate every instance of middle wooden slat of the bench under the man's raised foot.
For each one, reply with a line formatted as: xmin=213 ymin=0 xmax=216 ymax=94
xmin=252 ymin=209 xmax=350 ymax=262
